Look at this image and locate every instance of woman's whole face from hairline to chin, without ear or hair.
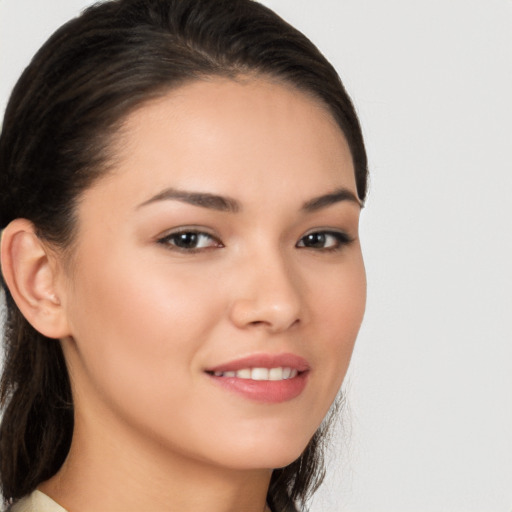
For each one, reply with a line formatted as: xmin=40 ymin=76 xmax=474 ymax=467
xmin=61 ymin=79 xmax=365 ymax=469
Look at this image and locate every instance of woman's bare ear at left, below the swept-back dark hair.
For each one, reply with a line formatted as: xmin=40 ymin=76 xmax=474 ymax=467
xmin=0 ymin=219 xmax=69 ymax=339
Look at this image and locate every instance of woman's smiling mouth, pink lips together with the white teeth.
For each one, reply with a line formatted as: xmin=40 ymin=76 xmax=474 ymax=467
xmin=205 ymin=354 xmax=310 ymax=403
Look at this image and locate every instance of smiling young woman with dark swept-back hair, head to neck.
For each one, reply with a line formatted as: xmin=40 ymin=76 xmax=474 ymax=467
xmin=0 ymin=0 xmax=367 ymax=512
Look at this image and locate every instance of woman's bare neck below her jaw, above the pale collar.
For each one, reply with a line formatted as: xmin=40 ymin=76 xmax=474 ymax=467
xmin=39 ymin=406 xmax=272 ymax=512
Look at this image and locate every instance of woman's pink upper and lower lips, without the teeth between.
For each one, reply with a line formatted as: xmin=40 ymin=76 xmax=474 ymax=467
xmin=205 ymin=354 xmax=311 ymax=404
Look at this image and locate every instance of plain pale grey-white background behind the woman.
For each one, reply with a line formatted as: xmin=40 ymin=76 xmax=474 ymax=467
xmin=0 ymin=0 xmax=512 ymax=512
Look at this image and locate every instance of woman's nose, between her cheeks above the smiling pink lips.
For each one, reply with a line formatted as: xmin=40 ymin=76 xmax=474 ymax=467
xmin=230 ymin=251 xmax=303 ymax=333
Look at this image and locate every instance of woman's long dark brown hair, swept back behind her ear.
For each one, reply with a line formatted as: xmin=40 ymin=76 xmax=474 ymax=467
xmin=0 ymin=0 xmax=367 ymax=512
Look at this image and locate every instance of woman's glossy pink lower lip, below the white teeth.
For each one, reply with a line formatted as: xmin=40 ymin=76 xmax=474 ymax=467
xmin=209 ymin=371 xmax=309 ymax=404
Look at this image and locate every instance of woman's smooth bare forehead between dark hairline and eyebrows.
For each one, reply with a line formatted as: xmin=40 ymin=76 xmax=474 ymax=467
xmin=88 ymin=78 xmax=355 ymax=210
